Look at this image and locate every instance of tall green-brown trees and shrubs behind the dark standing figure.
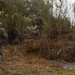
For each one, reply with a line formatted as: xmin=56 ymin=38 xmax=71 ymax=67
xmin=0 ymin=0 xmax=74 ymax=39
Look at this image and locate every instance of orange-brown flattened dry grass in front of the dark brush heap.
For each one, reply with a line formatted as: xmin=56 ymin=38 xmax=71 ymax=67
xmin=0 ymin=40 xmax=63 ymax=75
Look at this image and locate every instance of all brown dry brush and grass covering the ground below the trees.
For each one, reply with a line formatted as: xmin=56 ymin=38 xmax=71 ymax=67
xmin=0 ymin=38 xmax=75 ymax=75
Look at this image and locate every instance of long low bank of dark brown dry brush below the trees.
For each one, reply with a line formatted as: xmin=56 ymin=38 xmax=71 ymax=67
xmin=4 ymin=39 xmax=75 ymax=62
